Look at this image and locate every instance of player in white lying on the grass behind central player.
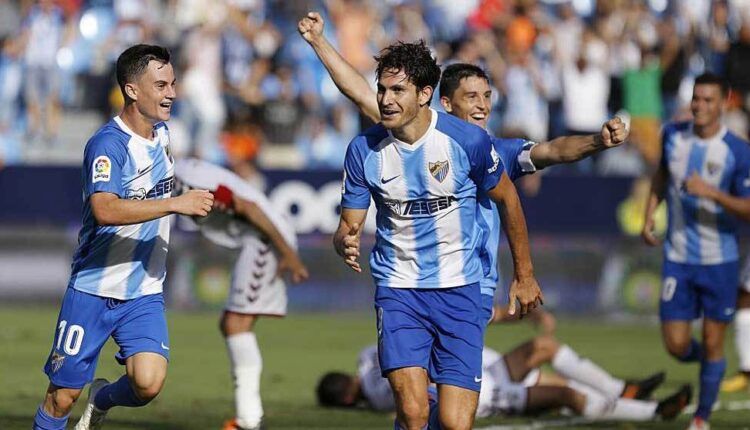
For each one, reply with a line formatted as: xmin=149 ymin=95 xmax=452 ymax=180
xmin=316 ymin=335 xmax=692 ymax=421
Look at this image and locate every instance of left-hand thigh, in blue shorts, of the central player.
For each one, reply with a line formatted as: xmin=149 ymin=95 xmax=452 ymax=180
xmin=375 ymin=287 xmax=435 ymax=375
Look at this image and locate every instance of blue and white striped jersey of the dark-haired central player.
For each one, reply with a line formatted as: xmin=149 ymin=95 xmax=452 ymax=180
xmin=341 ymin=111 xmax=504 ymax=288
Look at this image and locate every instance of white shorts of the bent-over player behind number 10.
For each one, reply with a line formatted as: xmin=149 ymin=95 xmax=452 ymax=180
xmin=224 ymin=241 xmax=287 ymax=316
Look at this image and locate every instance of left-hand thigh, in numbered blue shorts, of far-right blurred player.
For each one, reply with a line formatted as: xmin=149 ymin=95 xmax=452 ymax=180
xmin=659 ymin=260 xmax=701 ymax=322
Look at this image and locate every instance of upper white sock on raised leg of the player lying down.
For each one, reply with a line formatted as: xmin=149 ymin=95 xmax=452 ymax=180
xmin=552 ymin=345 xmax=625 ymax=397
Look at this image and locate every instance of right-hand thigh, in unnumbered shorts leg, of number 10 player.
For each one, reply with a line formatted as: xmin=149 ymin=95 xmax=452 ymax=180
xmin=112 ymin=294 xmax=170 ymax=364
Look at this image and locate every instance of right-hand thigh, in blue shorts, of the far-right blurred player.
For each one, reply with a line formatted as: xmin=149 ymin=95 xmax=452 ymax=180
xmin=696 ymin=261 xmax=739 ymax=323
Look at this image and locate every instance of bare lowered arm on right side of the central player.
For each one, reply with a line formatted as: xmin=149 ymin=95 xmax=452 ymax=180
xmin=488 ymin=171 xmax=543 ymax=315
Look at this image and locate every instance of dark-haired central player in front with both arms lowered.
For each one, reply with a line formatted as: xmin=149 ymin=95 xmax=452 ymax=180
xmin=334 ymin=41 xmax=542 ymax=429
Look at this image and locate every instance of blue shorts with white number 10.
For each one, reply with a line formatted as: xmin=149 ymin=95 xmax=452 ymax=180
xmin=44 ymin=288 xmax=169 ymax=388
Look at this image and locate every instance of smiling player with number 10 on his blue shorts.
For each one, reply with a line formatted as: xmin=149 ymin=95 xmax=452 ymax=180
xmin=33 ymin=45 xmax=213 ymax=430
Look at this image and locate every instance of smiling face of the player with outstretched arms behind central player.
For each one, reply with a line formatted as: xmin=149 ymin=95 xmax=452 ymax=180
xmin=440 ymin=76 xmax=492 ymax=128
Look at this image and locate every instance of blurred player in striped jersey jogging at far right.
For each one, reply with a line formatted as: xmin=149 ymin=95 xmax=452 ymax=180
xmin=643 ymin=74 xmax=750 ymax=430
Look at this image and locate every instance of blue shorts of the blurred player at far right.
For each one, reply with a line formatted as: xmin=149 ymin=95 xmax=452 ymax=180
xmin=659 ymin=260 xmax=739 ymax=322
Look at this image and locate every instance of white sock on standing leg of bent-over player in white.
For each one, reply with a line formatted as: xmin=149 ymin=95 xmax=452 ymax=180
xmin=227 ymin=332 xmax=263 ymax=427
